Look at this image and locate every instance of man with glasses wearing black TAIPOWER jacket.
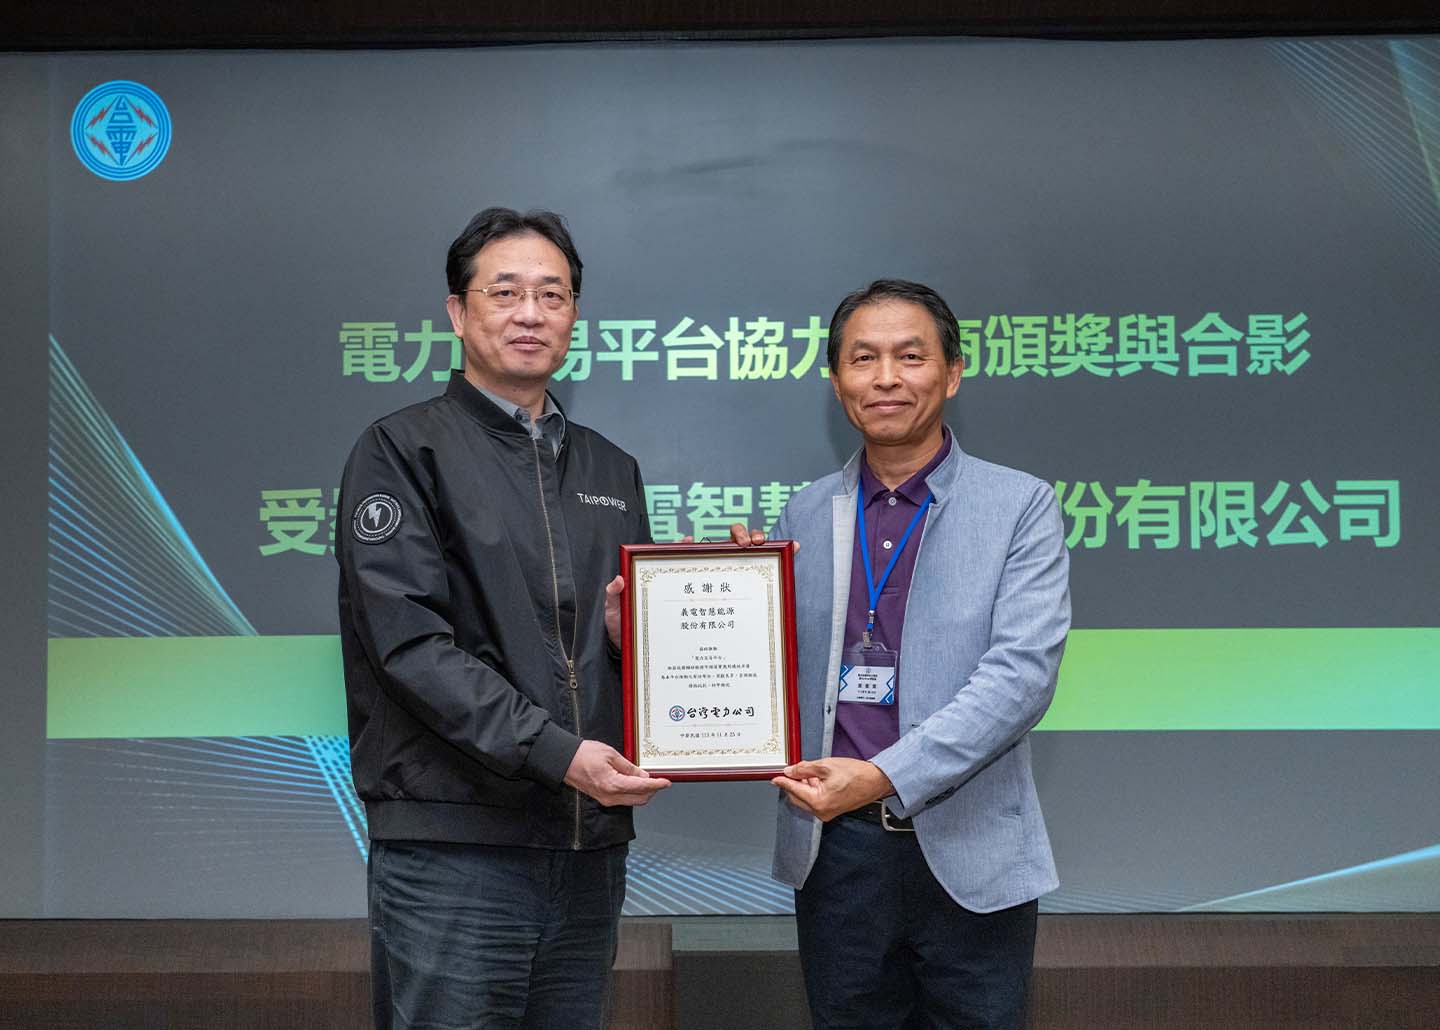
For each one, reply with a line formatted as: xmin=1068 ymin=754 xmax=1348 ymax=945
xmin=336 ymin=207 xmax=668 ymax=1030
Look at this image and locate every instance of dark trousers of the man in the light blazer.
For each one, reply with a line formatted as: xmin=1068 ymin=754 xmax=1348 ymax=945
xmin=795 ymin=815 xmax=1040 ymax=1030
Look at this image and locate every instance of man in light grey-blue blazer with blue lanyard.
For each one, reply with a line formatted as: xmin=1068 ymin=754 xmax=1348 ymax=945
xmin=734 ymin=279 xmax=1070 ymax=1030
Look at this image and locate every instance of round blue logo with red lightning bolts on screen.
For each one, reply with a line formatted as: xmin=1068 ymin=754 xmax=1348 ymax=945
xmin=71 ymin=79 xmax=170 ymax=183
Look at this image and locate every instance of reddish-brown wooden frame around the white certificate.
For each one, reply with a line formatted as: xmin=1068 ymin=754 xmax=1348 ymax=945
xmin=621 ymin=540 xmax=801 ymax=781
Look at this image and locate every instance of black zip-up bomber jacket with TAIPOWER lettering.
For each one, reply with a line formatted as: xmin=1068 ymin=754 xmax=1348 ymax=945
xmin=336 ymin=372 xmax=649 ymax=848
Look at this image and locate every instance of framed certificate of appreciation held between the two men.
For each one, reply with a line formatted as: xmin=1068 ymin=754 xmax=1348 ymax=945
xmin=621 ymin=542 xmax=801 ymax=779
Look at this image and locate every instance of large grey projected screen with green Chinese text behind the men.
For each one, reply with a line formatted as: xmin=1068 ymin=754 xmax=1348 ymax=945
xmin=0 ymin=39 xmax=1440 ymax=916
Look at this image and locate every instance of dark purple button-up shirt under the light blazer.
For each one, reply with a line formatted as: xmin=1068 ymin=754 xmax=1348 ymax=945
xmin=831 ymin=428 xmax=950 ymax=759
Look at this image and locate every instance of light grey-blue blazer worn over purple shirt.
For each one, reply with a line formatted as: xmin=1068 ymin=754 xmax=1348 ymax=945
xmin=772 ymin=444 xmax=1070 ymax=912
